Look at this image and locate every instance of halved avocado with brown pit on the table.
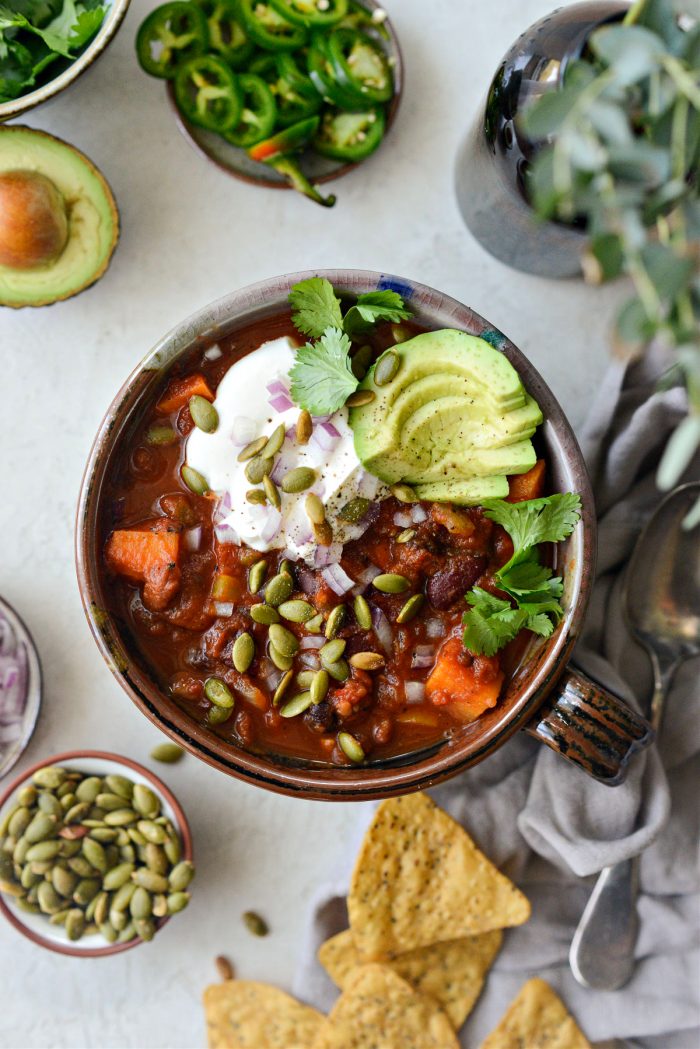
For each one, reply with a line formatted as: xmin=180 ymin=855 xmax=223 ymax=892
xmin=0 ymin=126 xmax=119 ymax=307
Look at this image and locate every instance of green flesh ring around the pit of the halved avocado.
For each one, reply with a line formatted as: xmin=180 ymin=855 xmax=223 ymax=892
xmin=0 ymin=126 xmax=119 ymax=307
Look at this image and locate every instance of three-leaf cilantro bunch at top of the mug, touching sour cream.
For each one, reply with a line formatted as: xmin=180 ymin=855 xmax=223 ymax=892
xmin=290 ymin=277 xmax=410 ymax=415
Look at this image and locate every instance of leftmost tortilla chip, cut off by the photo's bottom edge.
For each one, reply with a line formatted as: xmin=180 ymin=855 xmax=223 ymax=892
xmin=204 ymin=980 xmax=325 ymax=1049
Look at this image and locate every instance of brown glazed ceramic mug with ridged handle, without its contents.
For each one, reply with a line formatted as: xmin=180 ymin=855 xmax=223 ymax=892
xmin=77 ymin=270 xmax=652 ymax=800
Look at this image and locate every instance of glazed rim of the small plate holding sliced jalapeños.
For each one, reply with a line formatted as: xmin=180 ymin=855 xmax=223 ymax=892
xmin=166 ymin=0 xmax=405 ymax=190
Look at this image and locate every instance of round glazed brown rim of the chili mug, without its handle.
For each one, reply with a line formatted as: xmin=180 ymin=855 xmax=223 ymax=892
xmin=76 ymin=270 xmax=596 ymax=800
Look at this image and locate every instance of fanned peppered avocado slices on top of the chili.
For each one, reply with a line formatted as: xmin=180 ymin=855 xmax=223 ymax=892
xmin=349 ymin=328 xmax=543 ymax=506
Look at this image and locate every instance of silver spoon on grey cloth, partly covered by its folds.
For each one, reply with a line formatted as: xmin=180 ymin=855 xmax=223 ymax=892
xmin=569 ymin=481 xmax=700 ymax=990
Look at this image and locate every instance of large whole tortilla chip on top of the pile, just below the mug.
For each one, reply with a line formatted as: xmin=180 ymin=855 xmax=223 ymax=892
xmin=347 ymin=794 xmax=530 ymax=961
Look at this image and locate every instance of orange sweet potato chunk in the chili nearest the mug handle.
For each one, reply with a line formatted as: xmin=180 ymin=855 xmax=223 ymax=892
xmin=425 ymin=638 xmax=504 ymax=722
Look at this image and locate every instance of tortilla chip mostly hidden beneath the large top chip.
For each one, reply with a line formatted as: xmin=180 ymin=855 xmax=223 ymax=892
xmin=318 ymin=929 xmax=503 ymax=1029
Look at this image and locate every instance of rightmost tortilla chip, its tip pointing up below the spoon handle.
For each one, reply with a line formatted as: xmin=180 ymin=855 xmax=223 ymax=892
xmin=482 ymin=980 xmax=591 ymax=1049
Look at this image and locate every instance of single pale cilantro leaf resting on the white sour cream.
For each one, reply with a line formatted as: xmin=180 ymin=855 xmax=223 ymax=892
xmin=290 ymin=327 xmax=359 ymax=415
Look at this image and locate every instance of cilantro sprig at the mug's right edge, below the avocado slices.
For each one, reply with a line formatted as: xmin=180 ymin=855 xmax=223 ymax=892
xmin=463 ymin=492 xmax=580 ymax=656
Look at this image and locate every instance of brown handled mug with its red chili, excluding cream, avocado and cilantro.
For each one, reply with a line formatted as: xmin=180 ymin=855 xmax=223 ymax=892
xmin=77 ymin=271 xmax=651 ymax=800
